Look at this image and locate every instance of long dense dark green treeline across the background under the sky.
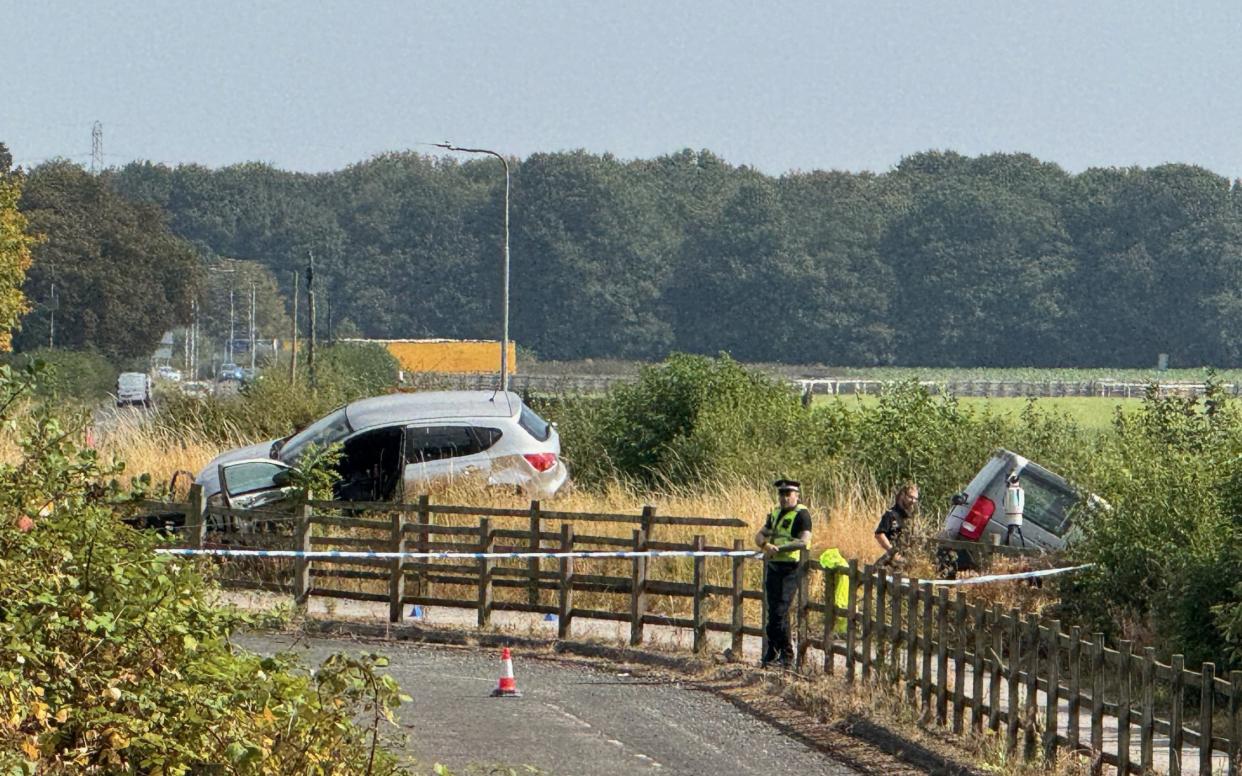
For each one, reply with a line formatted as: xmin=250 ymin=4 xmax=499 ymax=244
xmin=21 ymin=150 xmax=1242 ymax=366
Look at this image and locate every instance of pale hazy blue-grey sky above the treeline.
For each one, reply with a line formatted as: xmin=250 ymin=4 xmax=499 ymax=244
xmin=0 ymin=0 xmax=1242 ymax=178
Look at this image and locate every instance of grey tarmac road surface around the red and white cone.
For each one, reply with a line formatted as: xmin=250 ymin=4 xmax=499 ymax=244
xmin=237 ymin=634 xmax=854 ymax=776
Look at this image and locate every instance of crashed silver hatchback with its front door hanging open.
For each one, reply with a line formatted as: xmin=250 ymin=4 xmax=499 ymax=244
xmin=196 ymin=391 xmax=569 ymax=509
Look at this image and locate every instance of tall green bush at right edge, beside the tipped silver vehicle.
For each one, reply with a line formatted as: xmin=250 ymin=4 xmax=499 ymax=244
xmin=1064 ymin=377 xmax=1242 ymax=663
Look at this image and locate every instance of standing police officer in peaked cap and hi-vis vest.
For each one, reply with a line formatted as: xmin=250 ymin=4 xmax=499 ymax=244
xmin=755 ymin=479 xmax=811 ymax=668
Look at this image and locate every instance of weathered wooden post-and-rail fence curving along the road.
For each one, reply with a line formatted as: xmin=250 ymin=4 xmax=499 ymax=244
xmin=142 ymin=487 xmax=1242 ymax=776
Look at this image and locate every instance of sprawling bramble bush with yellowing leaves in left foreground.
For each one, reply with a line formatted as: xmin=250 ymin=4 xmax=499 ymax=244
xmin=0 ymin=365 xmax=412 ymax=776
